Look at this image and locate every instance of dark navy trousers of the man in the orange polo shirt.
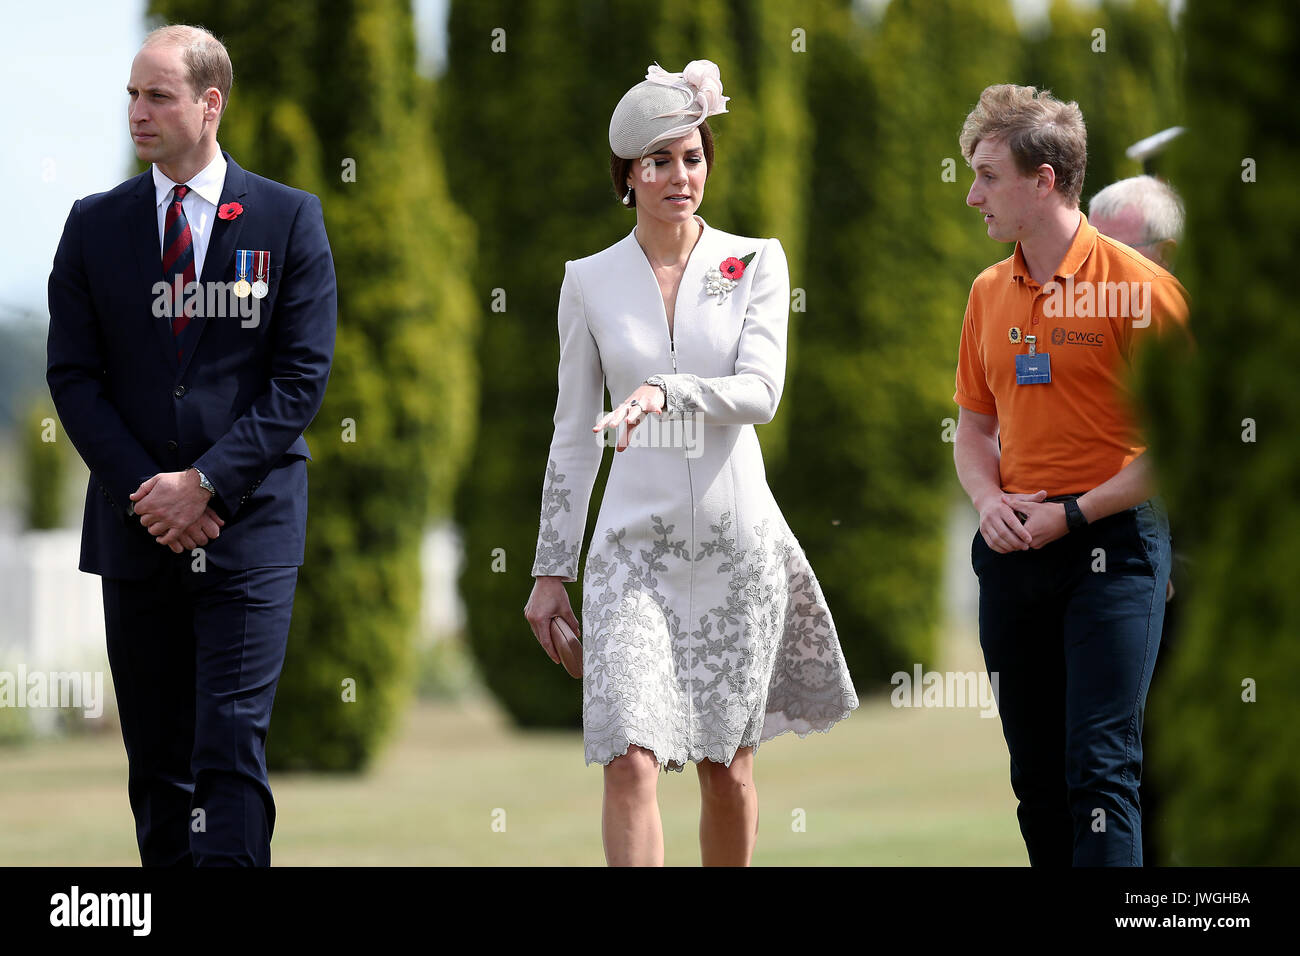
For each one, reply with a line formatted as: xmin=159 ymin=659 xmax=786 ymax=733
xmin=971 ymin=499 xmax=1170 ymax=866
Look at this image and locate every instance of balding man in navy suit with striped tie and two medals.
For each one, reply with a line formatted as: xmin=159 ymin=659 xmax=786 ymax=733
xmin=47 ymin=26 xmax=335 ymax=866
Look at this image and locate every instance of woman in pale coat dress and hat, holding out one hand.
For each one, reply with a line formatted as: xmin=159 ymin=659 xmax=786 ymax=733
xmin=525 ymin=60 xmax=858 ymax=865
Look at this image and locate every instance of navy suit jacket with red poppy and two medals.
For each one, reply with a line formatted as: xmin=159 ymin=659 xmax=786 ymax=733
xmin=46 ymin=151 xmax=337 ymax=579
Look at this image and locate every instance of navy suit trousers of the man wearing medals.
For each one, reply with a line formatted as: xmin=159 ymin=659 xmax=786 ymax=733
xmin=103 ymin=545 xmax=298 ymax=866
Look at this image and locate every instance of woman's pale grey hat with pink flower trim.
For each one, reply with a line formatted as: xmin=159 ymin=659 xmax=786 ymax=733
xmin=610 ymin=60 xmax=731 ymax=159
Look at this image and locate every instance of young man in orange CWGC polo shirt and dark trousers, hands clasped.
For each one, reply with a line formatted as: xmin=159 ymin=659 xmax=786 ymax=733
xmin=954 ymin=85 xmax=1187 ymax=866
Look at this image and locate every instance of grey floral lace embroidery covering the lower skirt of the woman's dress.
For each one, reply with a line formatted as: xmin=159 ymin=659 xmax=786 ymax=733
xmin=582 ymin=511 xmax=858 ymax=771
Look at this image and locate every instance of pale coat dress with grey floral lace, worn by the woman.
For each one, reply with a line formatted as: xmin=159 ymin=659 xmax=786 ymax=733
xmin=533 ymin=217 xmax=858 ymax=771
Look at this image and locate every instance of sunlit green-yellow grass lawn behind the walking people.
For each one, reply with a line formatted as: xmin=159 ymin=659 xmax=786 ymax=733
xmin=0 ymin=681 xmax=1026 ymax=866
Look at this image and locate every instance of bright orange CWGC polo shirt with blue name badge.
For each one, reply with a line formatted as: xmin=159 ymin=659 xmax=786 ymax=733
xmin=953 ymin=213 xmax=1188 ymax=496
